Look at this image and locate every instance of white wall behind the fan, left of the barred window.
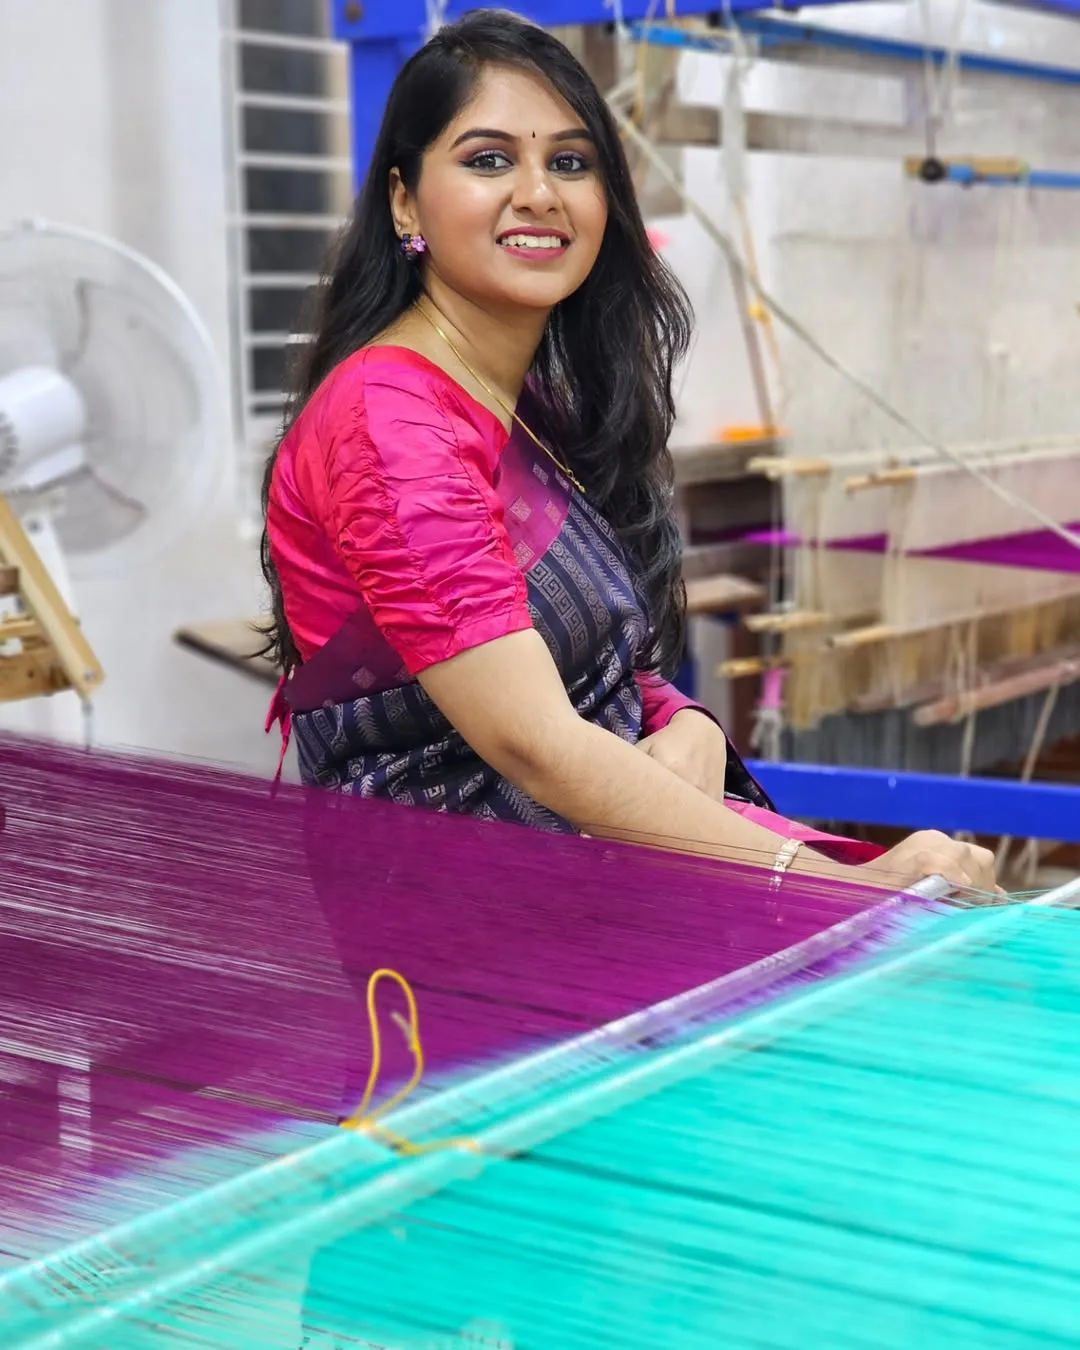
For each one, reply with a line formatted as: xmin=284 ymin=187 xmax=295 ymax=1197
xmin=0 ymin=0 xmax=275 ymax=768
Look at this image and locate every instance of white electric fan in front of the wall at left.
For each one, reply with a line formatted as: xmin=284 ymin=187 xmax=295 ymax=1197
xmin=0 ymin=221 xmax=223 ymax=740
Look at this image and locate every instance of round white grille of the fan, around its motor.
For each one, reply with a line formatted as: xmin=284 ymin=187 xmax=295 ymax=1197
xmin=0 ymin=223 xmax=227 ymax=566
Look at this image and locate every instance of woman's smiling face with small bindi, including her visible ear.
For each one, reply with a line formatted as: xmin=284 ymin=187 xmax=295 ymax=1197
xmin=392 ymin=66 xmax=608 ymax=311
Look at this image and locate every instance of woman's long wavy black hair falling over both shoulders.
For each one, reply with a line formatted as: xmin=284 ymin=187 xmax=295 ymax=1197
xmin=262 ymin=9 xmax=693 ymax=675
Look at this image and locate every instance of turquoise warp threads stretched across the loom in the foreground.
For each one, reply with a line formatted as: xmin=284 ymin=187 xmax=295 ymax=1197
xmin=12 ymin=907 xmax=1080 ymax=1350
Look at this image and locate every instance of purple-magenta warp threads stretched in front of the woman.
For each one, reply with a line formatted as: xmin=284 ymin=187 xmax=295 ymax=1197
xmin=0 ymin=740 xmax=896 ymax=1256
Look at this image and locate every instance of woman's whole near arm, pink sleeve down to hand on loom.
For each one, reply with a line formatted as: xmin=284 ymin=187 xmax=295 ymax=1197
xmin=311 ymin=369 xmax=991 ymax=887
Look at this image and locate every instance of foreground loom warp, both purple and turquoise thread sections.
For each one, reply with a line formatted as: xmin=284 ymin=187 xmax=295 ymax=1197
xmin=0 ymin=740 xmax=1080 ymax=1350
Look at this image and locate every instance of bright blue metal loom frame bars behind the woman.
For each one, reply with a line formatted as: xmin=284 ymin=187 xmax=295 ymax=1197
xmin=331 ymin=0 xmax=1080 ymax=844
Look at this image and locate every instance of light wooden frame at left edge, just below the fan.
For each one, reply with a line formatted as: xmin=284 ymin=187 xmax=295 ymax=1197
xmin=0 ymin=497 xmax=105 ymax=703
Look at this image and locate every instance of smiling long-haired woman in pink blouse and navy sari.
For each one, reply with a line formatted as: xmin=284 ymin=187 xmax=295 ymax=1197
xmin=263 ymin=11 xmax=994 ymax=888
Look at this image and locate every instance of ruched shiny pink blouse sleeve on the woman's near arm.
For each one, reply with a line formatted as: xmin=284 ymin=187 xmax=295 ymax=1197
xmin=320 ymin=363 xmax=532 ymax=675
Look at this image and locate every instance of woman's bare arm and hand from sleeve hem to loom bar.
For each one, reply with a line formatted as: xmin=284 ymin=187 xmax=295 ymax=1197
xmin=420 ymin=632 xmax=992 ymax=888
